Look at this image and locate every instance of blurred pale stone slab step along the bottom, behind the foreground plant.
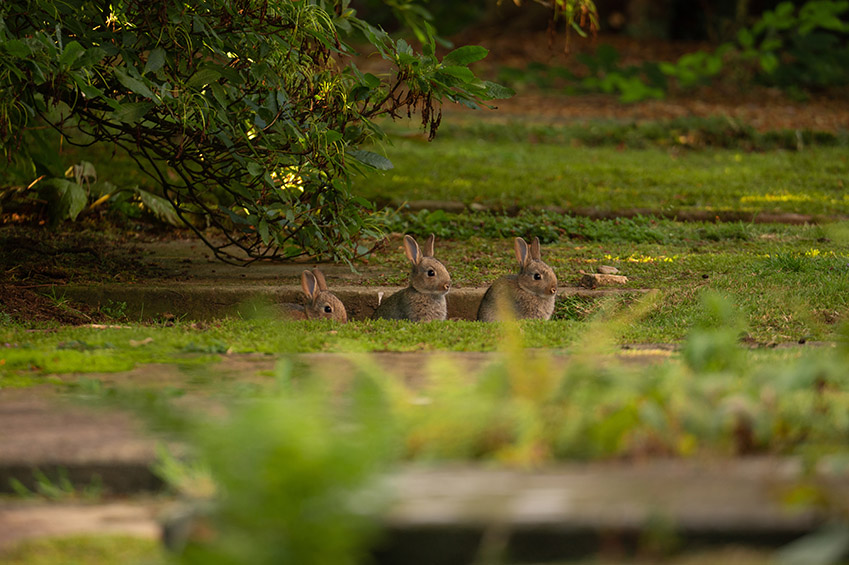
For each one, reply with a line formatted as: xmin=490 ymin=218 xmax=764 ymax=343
xmin=0 ymin=458 xmax=849 ymax=565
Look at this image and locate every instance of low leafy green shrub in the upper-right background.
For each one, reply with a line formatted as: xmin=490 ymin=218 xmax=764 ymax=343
xmin=500 ymin=0 xmax=849 ymax=103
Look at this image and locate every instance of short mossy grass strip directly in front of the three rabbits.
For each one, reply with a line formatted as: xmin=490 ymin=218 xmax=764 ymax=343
xmin=0 ymin=320 xmax=580 ymax=382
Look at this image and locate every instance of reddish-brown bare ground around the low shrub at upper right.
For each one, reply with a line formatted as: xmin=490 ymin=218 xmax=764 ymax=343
xmin=445 ymin=28 xmax=849 ymax=132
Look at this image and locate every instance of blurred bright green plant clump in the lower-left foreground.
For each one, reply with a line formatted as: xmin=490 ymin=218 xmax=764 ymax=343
xmin=166 ymin=361 xmax=396 ymax=564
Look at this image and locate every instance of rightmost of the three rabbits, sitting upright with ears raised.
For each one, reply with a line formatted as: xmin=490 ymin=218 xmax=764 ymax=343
xmin=478 ymin=237 xmax=557 ymax=322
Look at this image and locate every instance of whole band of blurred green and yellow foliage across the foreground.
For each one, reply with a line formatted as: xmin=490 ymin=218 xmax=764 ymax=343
xmin=84 ymin=294 xmax=849 ymax=564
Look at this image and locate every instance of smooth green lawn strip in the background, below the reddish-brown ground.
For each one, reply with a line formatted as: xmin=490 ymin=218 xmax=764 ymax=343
xmin=355 ymin=121 xmax=849 ymax=215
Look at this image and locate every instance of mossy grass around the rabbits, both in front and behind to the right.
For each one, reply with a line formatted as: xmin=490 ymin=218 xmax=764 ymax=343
xmin=0 ymin=216 xmax=849 ymax=388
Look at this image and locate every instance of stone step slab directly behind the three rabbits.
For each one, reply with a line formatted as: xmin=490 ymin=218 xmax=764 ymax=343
xmin=36 ymin=239 xmax=648 ymax=320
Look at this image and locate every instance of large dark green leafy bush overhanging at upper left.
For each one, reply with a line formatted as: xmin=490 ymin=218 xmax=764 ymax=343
xmin=0 ymin=0 xmax=511 ymax=261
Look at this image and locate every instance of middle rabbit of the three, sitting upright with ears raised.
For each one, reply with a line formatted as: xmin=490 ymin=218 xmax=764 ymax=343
xmin=372 ymin=234 xmax=451 ymax=322
